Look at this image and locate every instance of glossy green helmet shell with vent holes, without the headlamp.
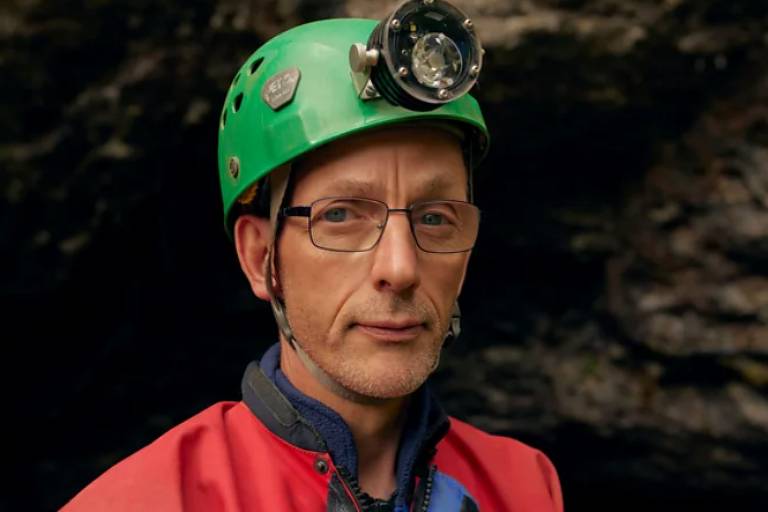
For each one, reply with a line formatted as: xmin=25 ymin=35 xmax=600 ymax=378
xmin=218 ymin=19 xmax=489 ymax=235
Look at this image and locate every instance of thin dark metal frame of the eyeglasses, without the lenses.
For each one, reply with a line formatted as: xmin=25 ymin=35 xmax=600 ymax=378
xmin=279 ymin=196 xmax=481 ymax=254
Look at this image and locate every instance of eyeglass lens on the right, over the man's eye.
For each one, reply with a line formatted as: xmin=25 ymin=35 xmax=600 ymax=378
xmin=411 ymin=201 xmax=480 ymax=252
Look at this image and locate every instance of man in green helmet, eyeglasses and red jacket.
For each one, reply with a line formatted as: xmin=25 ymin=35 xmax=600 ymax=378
xmin=64 ymin=2 xmax=562 ymax=512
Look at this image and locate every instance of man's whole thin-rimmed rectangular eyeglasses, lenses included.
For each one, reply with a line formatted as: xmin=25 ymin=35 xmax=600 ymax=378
xmin=280 ymin=197 xmax=480 ymax=253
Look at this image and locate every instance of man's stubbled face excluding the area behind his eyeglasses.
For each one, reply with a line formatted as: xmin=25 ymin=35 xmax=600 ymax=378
xmin=278 ymin=127 xmax=469 ymax=398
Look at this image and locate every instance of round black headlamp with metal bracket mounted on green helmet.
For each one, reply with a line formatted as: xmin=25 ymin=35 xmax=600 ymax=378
xmin=349 ymin=0 xmax=483 ymax=111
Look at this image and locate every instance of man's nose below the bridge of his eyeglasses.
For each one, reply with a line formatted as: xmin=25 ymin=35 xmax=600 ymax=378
xmin=371 ymin=212 xmax=420 ymax=293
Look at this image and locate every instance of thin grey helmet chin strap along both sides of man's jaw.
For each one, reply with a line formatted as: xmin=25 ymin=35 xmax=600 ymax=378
xmin=264 ymin=164 xmax=461 ymax=403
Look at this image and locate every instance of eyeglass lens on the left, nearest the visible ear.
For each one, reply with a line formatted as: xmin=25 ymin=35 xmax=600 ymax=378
xmin=310 ymin=197 xmax=387 ymax=251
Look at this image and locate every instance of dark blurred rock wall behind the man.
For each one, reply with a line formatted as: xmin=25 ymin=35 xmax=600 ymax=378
xmin=0 ymin=0 xmax=768 ymax=511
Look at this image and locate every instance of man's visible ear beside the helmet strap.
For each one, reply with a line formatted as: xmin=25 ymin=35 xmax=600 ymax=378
xmin=234 ymin=215 xmax=272 ymax=301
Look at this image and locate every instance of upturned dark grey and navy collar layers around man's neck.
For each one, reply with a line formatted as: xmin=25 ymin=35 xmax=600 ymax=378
xmin=242 ymin=343 xmax=449 ymax=504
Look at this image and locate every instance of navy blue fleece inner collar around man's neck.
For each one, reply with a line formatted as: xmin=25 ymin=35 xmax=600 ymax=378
xmin=260 ymin=343 xmax=448 ymax=506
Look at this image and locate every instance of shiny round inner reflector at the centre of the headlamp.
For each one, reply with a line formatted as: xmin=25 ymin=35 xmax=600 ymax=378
xmin=411 ymin=32 xmax=462 ymax=89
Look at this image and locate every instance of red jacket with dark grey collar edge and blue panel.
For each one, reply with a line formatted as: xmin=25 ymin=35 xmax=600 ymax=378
xmin=62 ymin=362 xmax=563 ymax=512
